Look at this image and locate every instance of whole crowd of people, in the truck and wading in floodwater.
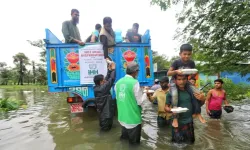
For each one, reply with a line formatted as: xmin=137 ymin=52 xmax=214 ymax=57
xmin=62 ymin=9 xmax=233 ymax=145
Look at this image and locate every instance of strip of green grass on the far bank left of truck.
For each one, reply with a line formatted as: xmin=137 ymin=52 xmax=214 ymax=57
xmin=0 ymin=84 xmax=47 ymax=90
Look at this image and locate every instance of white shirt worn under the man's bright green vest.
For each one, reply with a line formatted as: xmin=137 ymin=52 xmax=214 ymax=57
xmin=114 ymin=75 xmax=144 ymax=129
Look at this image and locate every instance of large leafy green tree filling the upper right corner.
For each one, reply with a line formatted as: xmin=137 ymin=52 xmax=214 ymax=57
xmin=151 ymin=0 xmax=250 ymax=75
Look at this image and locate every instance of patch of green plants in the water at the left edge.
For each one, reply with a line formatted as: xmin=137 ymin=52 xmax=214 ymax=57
xmin=0 ymin=98 xmax=25 ymax=111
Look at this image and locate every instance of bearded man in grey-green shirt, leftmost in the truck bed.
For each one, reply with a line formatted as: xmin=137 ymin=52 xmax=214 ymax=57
xmin=62 ymin=9 xmax=85 ymax=45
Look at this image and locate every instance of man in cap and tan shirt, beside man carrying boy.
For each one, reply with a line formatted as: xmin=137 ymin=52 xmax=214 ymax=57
xmin=147 ymin=76 xmax=171 ymax=127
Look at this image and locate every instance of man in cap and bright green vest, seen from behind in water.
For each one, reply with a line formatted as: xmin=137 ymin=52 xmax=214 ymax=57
xmin=115 ymin=62 xmax=143 ymax=145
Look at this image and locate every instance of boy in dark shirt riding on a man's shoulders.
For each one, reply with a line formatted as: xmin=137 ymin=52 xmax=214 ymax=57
xmin=167 ymin=44 xmax=206 ymax=127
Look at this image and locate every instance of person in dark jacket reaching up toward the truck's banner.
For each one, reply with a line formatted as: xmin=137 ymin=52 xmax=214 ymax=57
xmin=83 ymin=62 xmax=115 ymax=131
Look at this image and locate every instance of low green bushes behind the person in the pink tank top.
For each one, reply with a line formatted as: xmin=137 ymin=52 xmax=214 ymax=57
xmin=200 ymin=78 xmax=250 ymax=100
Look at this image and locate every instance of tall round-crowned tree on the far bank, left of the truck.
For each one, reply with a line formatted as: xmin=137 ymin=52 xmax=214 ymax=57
xmin=13 ymin=53 xmax=29 ymax=85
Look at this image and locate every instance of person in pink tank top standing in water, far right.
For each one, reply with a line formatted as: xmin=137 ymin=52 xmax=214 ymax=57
xmin=206 ymin=79 xmax=229 ymax=119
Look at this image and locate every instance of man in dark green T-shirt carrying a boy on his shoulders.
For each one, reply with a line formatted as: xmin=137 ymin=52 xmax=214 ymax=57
xmin=165 ymin=75 xmax=195 ymax=143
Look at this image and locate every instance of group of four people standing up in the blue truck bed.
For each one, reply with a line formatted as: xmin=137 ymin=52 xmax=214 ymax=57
xmin=62 ymin=9 xmax=141 ymax=61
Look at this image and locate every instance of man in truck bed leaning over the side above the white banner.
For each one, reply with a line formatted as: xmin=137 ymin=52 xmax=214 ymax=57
xmin=100 ymin=17 xmax=115 ymax=61
